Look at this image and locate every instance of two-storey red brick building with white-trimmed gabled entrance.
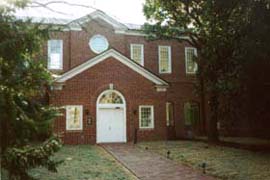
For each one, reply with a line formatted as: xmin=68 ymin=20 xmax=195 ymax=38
xmin=46 ymin=11 xmax=207 ymax=144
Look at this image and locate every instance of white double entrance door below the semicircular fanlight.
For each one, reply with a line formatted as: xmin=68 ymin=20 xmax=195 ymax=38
xmin=97 ymin=108 xmax=126 ymax=143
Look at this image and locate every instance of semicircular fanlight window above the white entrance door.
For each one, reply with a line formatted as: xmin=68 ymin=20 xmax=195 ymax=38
xmin=99 ymin=91 xmax=124 ymax=104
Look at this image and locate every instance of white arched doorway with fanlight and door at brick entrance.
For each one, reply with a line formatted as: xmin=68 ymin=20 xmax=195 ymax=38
xmin=96 ymin=90 xmax=127 ymax=143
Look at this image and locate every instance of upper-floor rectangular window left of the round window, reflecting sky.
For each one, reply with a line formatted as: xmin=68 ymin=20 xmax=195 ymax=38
xmin=48 ymin=40 xmax=63 ymax=70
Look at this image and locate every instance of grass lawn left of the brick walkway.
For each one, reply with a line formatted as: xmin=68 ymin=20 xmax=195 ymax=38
xmin=1 ymin=145 xmax=135 ymax=180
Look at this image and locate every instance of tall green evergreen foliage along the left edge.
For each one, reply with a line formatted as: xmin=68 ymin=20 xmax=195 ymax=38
xmin=0 ymin=1 xmax=62 ymax=179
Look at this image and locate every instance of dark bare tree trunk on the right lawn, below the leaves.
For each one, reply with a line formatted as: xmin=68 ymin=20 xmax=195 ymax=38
xmin=207 ymin=93 xmax=219 ymax=142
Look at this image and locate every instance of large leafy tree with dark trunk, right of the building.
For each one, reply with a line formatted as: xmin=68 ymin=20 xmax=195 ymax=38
xmin=144 ymin=0 xmax=270 ymax=141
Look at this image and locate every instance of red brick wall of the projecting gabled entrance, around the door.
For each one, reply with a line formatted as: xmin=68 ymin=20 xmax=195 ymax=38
xmin=50 ymin=58 xmax=166 ymax=144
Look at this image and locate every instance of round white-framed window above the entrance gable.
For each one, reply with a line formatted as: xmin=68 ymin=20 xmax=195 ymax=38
xmin=89 ymin=35 xmax=109 ymax=54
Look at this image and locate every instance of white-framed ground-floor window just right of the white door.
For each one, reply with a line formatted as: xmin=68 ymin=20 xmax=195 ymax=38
xmin=139 ymin=106 xmax=154 ymax=129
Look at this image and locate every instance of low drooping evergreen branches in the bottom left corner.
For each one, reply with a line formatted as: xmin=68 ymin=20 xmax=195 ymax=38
xmin=2 ymin=138 xmax=62 ymax=179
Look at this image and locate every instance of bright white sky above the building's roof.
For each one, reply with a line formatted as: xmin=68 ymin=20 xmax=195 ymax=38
xmin=12 ymin=0 xmax=146 ymax=24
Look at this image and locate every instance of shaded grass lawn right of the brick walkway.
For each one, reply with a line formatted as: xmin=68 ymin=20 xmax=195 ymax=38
xmin=138 ymin=141 xmax=270 ymax=180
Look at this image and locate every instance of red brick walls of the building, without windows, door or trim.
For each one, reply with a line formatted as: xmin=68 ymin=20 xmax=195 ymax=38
xmin=50 ymin=11 xmax=202 ymax=144
